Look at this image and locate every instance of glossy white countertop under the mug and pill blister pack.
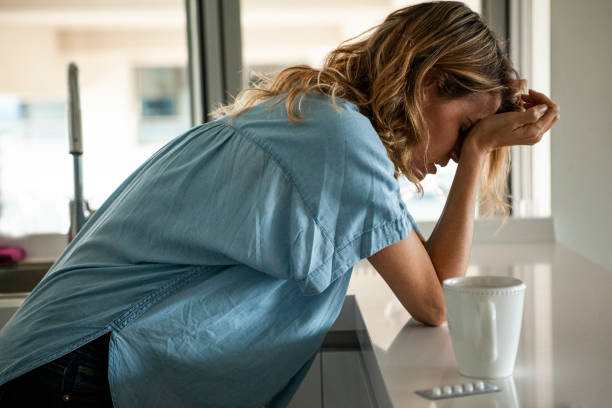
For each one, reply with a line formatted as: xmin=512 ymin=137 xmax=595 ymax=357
xmin=347 ymin=243 xmax=612 ymax=408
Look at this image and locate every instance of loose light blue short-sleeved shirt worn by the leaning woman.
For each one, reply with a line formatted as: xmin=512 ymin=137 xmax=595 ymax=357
xmin=0 ymin=93 xmax=417 ymax=407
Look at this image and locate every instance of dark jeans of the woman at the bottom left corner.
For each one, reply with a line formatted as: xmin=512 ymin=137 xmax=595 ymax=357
xmin=0 ymin=333 xmax=113 ymax=407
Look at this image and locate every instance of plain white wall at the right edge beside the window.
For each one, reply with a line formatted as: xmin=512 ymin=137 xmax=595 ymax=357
xmin=551 ymin=0 xmax=612 ymax=271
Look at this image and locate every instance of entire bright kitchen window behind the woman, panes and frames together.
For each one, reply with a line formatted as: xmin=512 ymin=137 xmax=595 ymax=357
xmin=0 ymin=0 xmax=550 ymax=245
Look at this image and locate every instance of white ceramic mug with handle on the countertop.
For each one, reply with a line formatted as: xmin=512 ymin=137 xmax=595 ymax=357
xmin=443 ymin=276 xmax=525 ymax=378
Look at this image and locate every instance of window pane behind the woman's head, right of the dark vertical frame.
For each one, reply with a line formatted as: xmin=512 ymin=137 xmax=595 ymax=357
xmin=241 ymin=0 xmax=480 ymax=221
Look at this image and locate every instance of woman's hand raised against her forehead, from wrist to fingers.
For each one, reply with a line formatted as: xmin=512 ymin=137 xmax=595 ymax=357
xmin=462 ymin=89 xmax=559 ymax=154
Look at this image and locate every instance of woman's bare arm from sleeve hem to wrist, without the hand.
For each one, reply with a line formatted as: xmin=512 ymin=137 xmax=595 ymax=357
xmin=368 ymin=146 xmax=484 ymax=326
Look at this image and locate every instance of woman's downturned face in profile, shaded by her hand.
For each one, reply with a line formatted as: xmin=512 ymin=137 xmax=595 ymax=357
xmin=413 ymin=84 xmax=501 ymax=177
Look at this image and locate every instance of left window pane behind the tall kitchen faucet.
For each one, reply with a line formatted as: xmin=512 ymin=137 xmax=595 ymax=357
xmin=0 ymin=0 xmax=191 ymax=236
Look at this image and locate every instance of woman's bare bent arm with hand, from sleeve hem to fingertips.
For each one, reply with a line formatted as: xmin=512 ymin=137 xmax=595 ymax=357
xmin=368 ymin=91 xmax=559 ymax=325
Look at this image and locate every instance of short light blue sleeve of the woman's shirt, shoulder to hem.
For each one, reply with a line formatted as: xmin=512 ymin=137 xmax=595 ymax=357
xmin=224 ymin=99 xmax=418 ymax=295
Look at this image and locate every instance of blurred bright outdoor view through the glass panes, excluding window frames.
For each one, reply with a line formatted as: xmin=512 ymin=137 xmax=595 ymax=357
xmin=0 ymin=0 xmax=480 ymax=235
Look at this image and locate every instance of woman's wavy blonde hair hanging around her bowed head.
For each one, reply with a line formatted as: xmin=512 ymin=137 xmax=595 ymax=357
xmin=212 ymin=1 xmax=525 ymax=216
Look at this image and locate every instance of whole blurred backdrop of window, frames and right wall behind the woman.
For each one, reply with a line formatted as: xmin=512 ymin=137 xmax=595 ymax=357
xmin=0 ymin=0 xmax=612 ymax=268
